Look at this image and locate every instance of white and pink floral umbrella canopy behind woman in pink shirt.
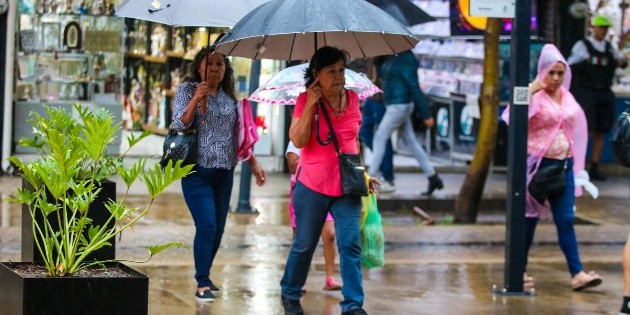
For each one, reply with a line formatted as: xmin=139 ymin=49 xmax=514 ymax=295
xmin=248 ymin=63 xmax=382 ymax=105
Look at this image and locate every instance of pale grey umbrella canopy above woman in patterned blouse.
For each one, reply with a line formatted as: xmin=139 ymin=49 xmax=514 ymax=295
xmin=116 ymin=0 xmax=268 ymax=26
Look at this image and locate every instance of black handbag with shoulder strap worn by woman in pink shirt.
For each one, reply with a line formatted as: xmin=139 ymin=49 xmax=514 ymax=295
xmin=315 ymin=100 xmax=368 ymax=196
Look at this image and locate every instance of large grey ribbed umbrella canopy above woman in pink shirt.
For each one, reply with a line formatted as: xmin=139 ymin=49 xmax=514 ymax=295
xmin=217 ymin=0 xmax=418 ymax=60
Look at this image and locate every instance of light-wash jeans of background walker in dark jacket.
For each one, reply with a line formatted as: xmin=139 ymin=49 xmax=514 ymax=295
xmin=368 ymin=103 xmax=435 ymax=177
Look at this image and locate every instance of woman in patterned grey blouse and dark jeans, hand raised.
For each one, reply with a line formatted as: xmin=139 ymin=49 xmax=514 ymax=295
xmin=171 ymin=47 xmax=267 ymax=302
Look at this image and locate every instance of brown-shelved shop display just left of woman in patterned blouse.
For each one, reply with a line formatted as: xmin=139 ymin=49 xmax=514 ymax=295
xmin=123 ymin=19 xmax=227 ymax=134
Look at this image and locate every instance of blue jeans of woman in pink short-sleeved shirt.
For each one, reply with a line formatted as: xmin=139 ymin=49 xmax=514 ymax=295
xmin=280 ymin=179 xmax=364 ymax=312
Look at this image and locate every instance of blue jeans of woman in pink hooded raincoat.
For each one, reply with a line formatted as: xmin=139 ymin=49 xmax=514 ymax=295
xmin=525 ymin=158 xmax=582 ymax=277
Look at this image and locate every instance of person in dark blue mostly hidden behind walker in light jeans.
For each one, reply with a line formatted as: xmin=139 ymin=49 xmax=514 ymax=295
xmin=359 ymin=89 xmax=396 ymax=193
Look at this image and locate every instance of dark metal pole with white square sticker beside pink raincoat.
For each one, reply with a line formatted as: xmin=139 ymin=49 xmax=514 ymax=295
xmin=502 ymin=0 xmax=531 ymax=294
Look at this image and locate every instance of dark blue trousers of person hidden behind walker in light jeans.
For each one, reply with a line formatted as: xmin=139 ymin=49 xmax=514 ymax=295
xmin=359 ymin=99 xmax=394 ymax=181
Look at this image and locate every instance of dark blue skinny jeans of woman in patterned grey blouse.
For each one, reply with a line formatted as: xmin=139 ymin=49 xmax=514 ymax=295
xmin=182 ymin=166 xmax=234 ymax=288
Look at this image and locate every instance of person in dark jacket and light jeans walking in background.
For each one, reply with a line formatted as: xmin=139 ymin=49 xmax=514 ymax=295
xmin=368 ymin=50 xmax=444 ymax=196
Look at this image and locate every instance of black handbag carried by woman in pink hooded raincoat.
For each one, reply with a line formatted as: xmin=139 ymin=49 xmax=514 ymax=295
xmin=528 ymin=159 xmax=567 ymax=204
